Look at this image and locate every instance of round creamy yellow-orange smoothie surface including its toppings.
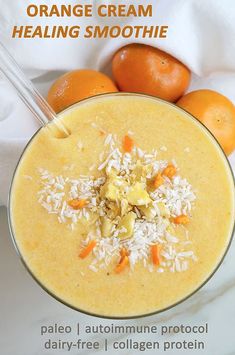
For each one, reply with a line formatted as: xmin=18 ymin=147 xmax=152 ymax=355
xmin=10 ymin=95 xmax=234 ymax=317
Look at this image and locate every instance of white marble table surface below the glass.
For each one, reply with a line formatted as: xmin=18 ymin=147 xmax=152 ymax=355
xmin=0 ymin=155 xmax=235 ymax=355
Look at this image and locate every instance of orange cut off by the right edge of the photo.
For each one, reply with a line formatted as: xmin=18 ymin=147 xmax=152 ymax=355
xmin=177 ymin=90 xmax=235 ymax=155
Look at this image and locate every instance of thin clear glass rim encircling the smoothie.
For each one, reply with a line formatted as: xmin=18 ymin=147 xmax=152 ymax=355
xmin=7 ymin=92 xmax=235 ymax=320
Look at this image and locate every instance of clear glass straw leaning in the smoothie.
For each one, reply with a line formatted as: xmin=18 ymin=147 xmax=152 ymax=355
xmin=0 ymin=41 xmax=69 ymax=136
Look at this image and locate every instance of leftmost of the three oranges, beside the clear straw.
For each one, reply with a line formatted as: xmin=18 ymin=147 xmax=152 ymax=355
xmin=47 ymin=69 xmax=118 ymax=113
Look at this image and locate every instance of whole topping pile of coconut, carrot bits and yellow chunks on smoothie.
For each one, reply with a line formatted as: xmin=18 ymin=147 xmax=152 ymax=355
xmin=38 ymin=133 xmax=197 ymax=273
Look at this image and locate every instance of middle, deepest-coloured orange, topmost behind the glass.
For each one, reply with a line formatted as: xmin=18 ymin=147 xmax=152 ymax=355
xmin=112 ymin=43 xmax=191 ymax=102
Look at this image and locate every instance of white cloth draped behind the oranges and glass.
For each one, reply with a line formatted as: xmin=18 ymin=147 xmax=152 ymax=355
xmin=0 ymin=0 xmax=235 ymax=204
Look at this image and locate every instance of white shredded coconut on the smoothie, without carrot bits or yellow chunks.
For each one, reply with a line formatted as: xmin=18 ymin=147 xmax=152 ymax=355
xmin=38 ymin=134 xmax=197 ymax=273
